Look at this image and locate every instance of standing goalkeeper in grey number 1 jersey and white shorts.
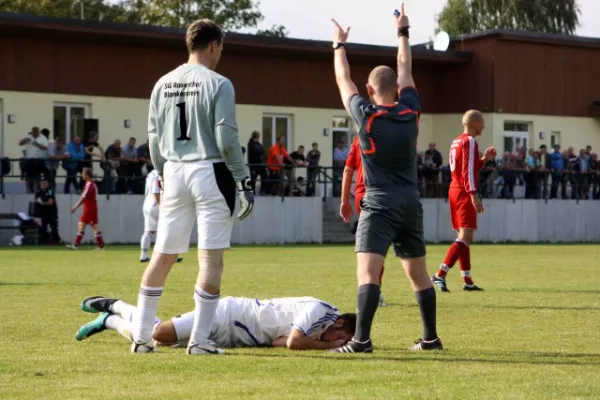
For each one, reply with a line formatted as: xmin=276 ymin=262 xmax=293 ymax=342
xmin=131 ymin=19 xmax=254 ymax=355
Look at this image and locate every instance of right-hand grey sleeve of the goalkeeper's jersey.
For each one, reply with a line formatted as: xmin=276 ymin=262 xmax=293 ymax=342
xmin=215 ymin=79 xmax=248 ymax=182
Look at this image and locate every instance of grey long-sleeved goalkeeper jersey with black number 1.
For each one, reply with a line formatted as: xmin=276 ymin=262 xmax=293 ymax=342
xmin=148 ymin=64 xmax=248 ymax=181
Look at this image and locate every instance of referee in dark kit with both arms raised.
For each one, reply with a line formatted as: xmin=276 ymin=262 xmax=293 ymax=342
xmin=333 ymin=5 xmax=442 ymax=353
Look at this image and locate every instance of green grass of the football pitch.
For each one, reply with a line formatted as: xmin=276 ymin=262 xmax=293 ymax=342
xmin=0 ymin=245 xmax=600 ymax=399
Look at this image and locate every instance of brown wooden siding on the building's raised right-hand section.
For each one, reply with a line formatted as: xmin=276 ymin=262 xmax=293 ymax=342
xmin=494 ymin=40 xmax=600 ymax=117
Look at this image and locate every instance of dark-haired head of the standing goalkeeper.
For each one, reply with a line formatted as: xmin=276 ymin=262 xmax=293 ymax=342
xmin=185 ymin=18 xmax=225 ymax=70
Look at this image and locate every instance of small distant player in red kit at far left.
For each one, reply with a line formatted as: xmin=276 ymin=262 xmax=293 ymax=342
xmin=67 ymin=168 xmax=104 ymax=250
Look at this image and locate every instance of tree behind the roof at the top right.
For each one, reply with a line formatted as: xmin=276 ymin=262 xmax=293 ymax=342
xmin=437 ymin=0 xmax=581 ymax=36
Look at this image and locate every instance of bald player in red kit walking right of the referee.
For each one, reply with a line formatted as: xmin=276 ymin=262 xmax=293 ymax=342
xmin=432 ymin=110 xmax=496 ymax=292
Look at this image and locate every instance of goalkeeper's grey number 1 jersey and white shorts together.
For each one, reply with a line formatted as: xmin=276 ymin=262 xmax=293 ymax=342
xmin=148 ymin=64 xmax=248 ymax=254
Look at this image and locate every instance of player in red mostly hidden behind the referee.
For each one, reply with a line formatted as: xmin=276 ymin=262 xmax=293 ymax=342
xmin=340 ymin=136 xmax=387 ymax=307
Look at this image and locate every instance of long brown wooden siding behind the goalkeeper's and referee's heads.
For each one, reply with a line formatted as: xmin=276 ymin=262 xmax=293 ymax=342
xmin=0 ymin=32 xmax=435 ymax=112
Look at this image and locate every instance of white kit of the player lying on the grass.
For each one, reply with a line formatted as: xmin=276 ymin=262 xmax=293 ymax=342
xmin=171 ymin=297 xmax=340 ymax=348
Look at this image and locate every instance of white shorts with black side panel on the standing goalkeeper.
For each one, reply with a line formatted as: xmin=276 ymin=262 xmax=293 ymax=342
xmin=154 ymin=161 xmax=237 ymax=254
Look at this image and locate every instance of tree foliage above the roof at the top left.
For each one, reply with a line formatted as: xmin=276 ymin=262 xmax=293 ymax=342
xmin=0 ymin=0 xmax=287 ymax=37
